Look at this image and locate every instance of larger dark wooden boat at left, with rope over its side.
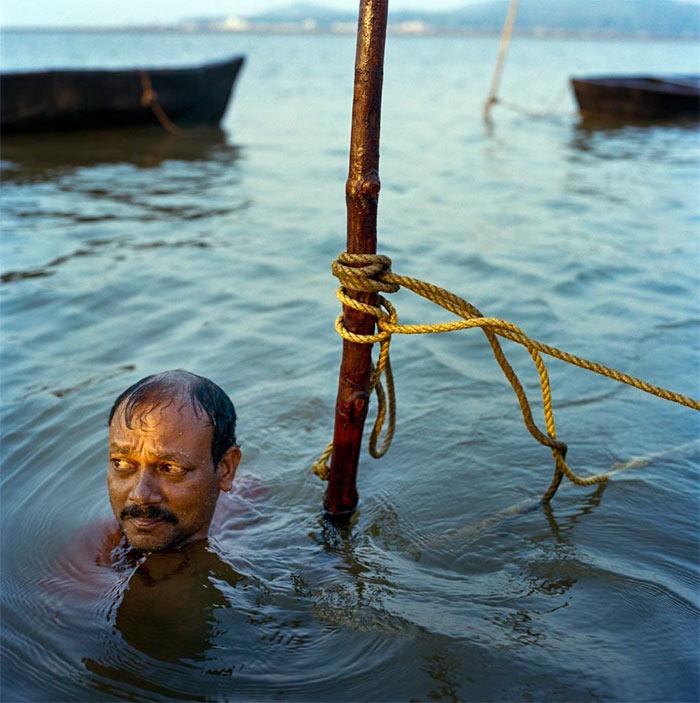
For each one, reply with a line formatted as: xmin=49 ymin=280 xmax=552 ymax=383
xmin=0 ymin=56 xmax=244 ymax=134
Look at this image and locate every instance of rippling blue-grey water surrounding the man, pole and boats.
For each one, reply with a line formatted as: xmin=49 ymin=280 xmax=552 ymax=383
xmin=0 ymin=28 xmax=700 ymax=702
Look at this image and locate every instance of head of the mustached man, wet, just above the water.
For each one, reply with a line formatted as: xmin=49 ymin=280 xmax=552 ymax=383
xmin=107 ymin=371 xmax=241 ymax=551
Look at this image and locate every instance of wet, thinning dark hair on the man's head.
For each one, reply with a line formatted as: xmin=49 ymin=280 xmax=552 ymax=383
xmin=107 ymin=369 xmax=236 ymax=469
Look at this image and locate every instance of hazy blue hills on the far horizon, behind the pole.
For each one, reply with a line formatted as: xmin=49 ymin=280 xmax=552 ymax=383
xmin=239 ymin=0 xmax=700 ymax=38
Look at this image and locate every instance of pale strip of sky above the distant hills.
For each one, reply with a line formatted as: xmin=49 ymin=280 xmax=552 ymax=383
xmin=0 ymin=0 xmax=477 ymax=27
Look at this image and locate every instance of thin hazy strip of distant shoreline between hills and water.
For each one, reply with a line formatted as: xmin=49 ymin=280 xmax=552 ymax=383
xmin=0 ymin=25 xmax=700 ymax=43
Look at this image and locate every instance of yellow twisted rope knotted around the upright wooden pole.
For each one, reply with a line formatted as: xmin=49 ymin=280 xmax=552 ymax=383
xmin=312 ymin=253 xmax=700 ymax=501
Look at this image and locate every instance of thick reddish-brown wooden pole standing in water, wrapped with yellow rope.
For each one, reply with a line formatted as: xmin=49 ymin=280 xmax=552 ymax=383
xmin=324 ymin=0 xmax=389 ymax=520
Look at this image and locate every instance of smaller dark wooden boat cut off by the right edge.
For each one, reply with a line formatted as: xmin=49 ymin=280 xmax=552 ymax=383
xmin=571 ymin=76 xmax=700 ymax=120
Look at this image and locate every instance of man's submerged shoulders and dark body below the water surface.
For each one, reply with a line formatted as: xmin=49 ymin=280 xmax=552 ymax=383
xmin=56 ymin=481 xmax=265 ymax=673
